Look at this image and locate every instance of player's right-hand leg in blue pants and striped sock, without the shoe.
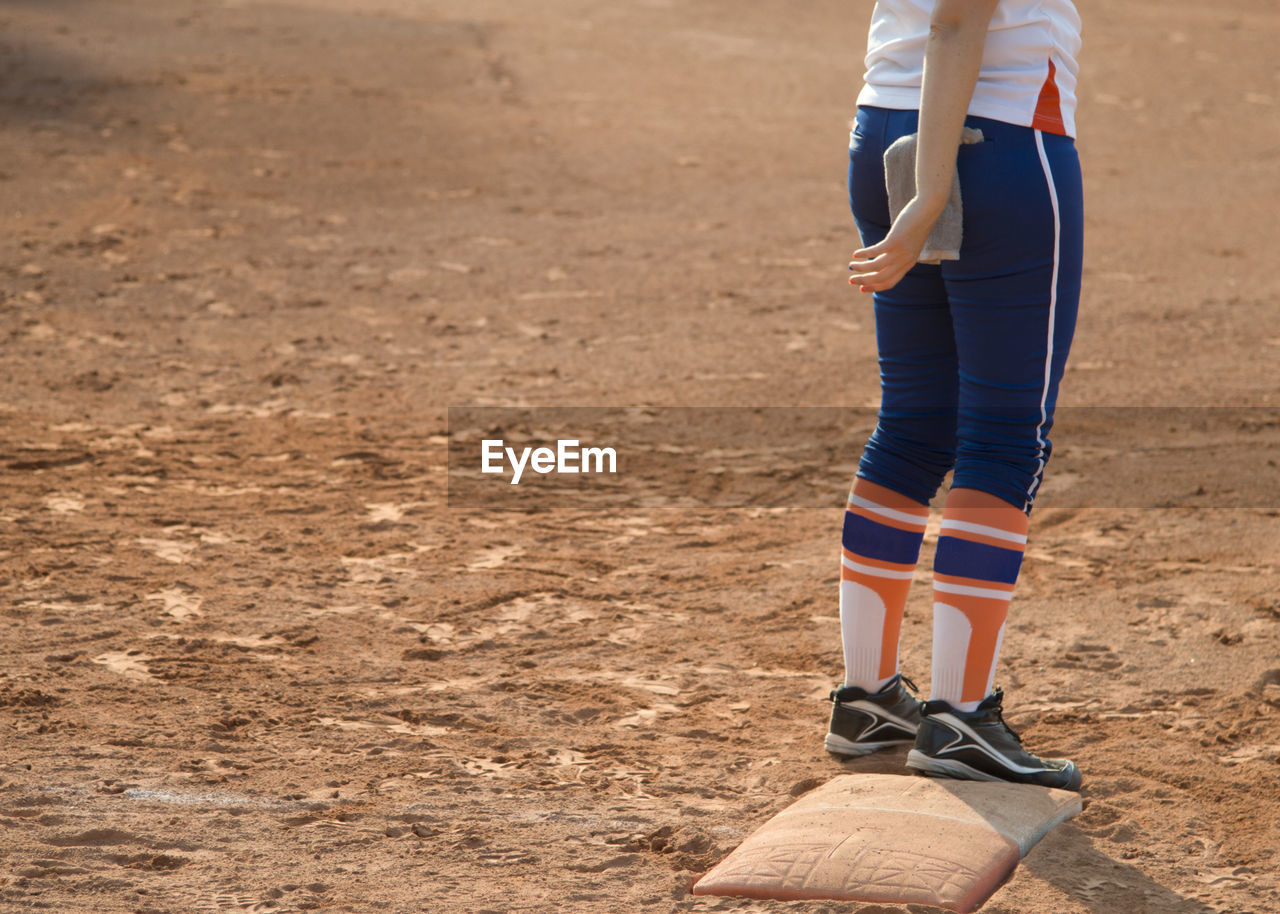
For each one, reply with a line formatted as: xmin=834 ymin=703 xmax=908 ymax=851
xmin=932 ymin=124 xmax=1083 ymax=710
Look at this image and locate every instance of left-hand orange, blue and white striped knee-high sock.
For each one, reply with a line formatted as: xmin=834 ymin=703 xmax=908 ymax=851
xmin=840 ymin=479 xmax=929 ymax=691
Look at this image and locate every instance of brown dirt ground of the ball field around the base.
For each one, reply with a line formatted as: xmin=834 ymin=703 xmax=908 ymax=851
xmin=0 ymin=0 xmax=1280 ymax=914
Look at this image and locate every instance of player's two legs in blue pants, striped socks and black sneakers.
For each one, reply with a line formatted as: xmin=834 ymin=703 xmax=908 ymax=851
xmin=827 ymin=109 xmax=1083 ymax=790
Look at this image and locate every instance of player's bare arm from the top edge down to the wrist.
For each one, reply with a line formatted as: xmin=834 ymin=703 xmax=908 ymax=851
xmin=915 ymin=0 xmax=998 ymax=212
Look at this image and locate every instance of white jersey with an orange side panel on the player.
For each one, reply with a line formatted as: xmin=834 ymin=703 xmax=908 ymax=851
xmin=858 ymin=0 xmax=1080 ymax=137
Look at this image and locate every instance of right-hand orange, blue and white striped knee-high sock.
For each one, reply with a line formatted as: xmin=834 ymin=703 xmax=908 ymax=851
xmin=929 ymin=489 xmax=1027 ymax=710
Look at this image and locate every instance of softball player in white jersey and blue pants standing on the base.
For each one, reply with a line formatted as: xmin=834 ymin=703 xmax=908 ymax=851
xmin=826 ymin=0 xmax=1083 ymax=790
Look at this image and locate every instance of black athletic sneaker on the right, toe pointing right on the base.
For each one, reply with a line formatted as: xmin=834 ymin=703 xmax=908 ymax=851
xmin=906 ymin=689 xmax=1080 ymax=790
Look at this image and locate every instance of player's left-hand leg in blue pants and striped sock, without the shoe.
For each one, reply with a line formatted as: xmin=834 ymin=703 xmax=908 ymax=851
xmin=840 ymin=109 xmax=957 ymax=693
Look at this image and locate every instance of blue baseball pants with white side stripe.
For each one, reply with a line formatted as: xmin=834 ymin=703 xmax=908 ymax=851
xmin=849 ymin=106 xmax=1084 ymax=512
